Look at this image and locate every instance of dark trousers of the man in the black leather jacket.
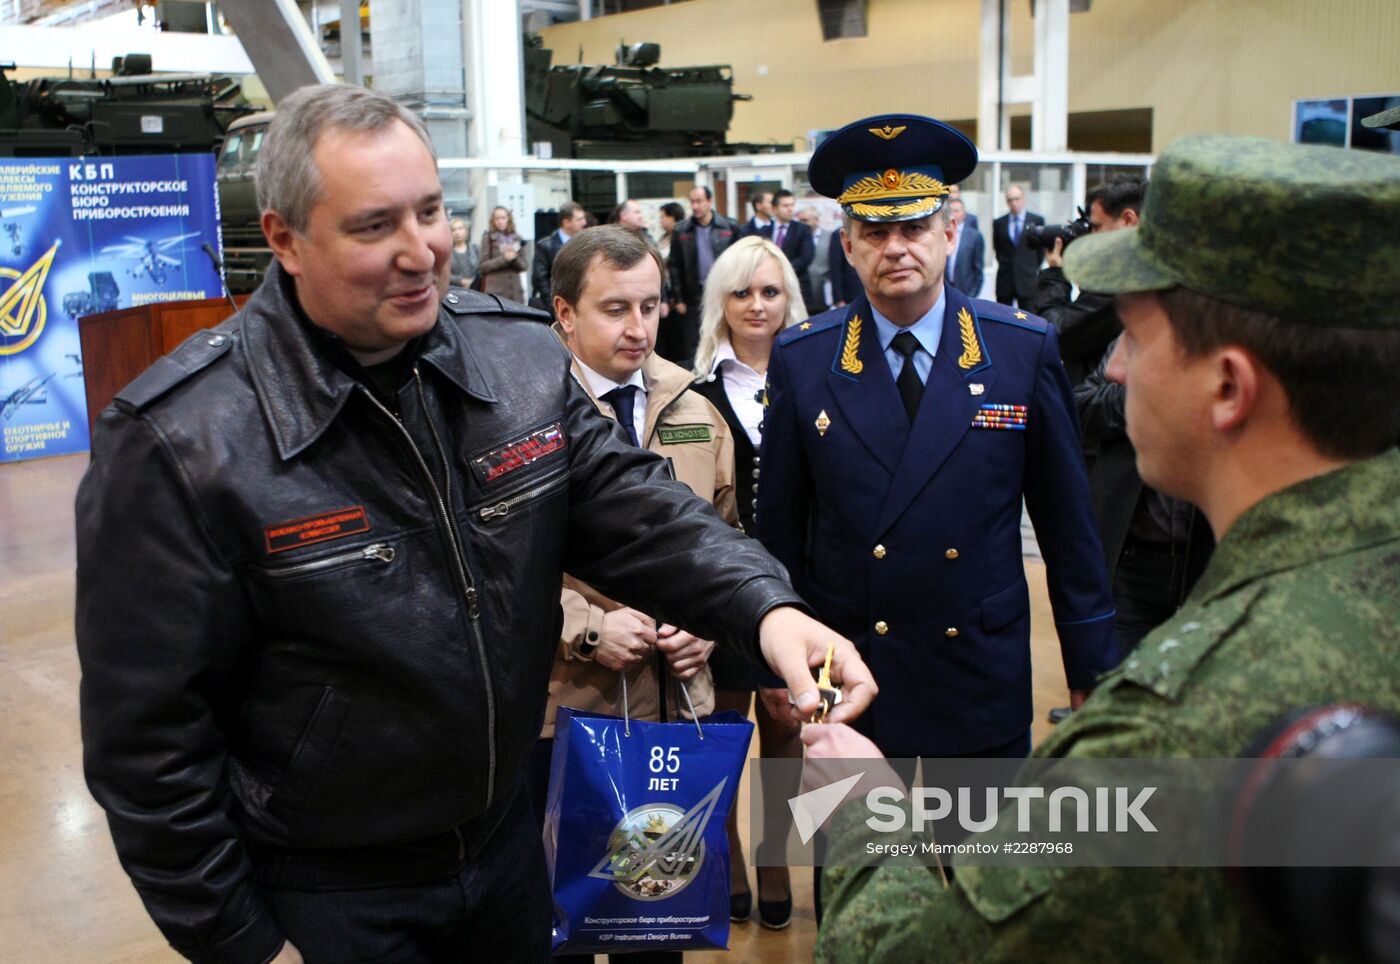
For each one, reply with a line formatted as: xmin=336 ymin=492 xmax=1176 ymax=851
xmin=255 ymin=789 xmax=552 ymax=964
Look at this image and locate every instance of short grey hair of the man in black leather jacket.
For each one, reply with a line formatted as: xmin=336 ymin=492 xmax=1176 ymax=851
xmin=256 ymin=84 xmax=437 ymax=234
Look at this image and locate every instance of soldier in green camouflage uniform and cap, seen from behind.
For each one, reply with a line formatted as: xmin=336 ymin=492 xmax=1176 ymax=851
xmin=804 ymin=137 xmax=1400 ymax=963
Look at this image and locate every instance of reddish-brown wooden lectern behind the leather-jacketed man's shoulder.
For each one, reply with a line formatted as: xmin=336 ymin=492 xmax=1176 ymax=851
xmin=78 ymin=295 xmax=248 ymax=432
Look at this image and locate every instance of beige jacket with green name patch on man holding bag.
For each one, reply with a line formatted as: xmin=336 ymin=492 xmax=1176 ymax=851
xmin=540 ymin=339 xmax=739 ymax=740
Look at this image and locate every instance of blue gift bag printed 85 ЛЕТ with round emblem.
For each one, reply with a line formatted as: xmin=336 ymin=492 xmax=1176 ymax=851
xmin=545 ymin=707 xmax=753 ymax=954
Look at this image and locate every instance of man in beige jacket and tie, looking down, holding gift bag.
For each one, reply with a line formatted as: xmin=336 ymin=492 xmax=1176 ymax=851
xmin=535 ymin=225 xmax=738 ymax=839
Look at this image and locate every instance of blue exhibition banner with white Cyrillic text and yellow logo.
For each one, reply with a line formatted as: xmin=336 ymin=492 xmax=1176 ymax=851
xmin=0 ymin=154 xmax=223 ymax=462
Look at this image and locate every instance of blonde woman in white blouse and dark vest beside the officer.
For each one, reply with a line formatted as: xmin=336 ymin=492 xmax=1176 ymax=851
xmin=694 ymin=236 xmax=806 ymax=930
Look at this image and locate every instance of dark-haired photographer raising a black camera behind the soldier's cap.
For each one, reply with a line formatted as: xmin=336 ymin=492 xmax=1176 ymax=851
xmin=1026 ymin=173 xmax=1147 ymax=385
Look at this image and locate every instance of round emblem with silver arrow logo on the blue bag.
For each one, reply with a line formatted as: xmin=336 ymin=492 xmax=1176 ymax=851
xmin=588 ymin=778 xmax=729 ymax=901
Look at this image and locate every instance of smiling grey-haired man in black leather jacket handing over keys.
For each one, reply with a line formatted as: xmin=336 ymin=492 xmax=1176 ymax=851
xmin=76 ymin=87 xmax=874 ymax=963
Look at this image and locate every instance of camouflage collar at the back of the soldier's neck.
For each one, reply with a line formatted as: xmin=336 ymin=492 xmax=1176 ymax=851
xmin=1191 ymin=448 xmax=1400 ymax=602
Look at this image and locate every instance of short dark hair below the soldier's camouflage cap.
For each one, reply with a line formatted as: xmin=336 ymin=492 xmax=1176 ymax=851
xmin=1159 ymin=288 xmax=1400 ymax=459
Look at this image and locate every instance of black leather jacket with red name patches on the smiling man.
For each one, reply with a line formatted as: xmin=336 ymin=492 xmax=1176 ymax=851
xmin=77 ymin=266 xmax=801 ymax=961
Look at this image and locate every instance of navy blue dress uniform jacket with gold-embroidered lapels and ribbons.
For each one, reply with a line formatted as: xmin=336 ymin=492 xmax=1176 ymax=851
xmin=755 ymin=287 xmax=1117 ymax=757
